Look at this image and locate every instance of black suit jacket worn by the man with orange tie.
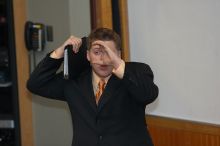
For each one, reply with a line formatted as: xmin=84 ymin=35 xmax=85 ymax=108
xmin=27 ymin=40 xmax=158 ymax=146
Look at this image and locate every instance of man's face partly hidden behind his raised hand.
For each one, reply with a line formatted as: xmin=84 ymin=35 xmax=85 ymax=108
xmin=87 ymin=41 xmax=120 ymax=78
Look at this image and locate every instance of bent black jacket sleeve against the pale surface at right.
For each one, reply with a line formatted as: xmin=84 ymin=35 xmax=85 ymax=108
xmin=123 ymin=62 xmax=159 ymax=105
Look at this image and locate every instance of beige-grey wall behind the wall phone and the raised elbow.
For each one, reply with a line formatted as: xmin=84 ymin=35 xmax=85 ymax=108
xmin=27 ymin=0 xmax=90 ymax=146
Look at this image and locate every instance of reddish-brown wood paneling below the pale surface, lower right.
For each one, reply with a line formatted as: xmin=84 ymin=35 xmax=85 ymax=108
xmin=147 ymin=116 xmax=220 ymax=146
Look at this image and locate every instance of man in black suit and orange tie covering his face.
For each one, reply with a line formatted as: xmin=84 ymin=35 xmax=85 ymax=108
xmin=27 ymin=28 xmax=158 ymax=146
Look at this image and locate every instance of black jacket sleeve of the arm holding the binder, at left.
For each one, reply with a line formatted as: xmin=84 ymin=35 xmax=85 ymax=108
xmin=27 ymin=54 xmax=65 ymax=100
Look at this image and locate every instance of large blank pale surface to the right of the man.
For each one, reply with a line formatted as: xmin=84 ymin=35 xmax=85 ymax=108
xmin=128 ymin=0 xmax=220 ymax=124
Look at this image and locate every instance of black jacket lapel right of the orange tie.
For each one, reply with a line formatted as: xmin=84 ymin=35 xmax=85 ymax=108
xmin=98 ymin=74 xmax=121 ymax=111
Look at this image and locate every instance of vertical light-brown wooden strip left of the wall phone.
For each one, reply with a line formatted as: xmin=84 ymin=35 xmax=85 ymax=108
xmin=13 ymin=0 xmax=33 ymax=146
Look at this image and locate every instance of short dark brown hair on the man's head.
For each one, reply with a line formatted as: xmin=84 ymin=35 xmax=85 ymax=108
xmin=87 ymin=28 xmax=121 ymax=50
